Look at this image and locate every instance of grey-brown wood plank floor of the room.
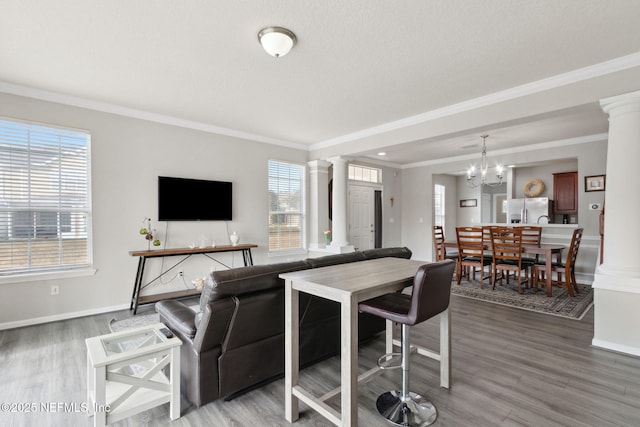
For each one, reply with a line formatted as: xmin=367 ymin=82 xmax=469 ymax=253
xmin=0 ymin=296 xmax=640 ymax=426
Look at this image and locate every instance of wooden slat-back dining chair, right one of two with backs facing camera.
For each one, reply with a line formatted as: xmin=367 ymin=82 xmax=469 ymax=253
xmin=491 ymin=227 xmax=529 ymax=294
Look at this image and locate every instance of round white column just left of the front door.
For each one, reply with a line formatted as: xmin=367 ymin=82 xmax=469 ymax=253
xmin=327 ymin=157 xmax=354 ymax=253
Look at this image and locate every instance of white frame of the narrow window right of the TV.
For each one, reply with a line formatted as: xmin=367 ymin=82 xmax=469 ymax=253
xmin=267 ymin=159 xmax=307 ymax=256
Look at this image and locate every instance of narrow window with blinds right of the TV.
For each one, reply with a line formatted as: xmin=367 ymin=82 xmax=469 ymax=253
xmin=269 ymin=160 xmax=305 ymax=252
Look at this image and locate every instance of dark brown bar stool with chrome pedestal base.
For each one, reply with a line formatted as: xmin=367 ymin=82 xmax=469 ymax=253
xmin=358 ymin=260 xmax=456 ymax=426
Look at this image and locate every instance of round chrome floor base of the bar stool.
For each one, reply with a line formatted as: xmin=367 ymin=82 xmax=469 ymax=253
xmin=376 ymin=391 xmax=438 ymax=427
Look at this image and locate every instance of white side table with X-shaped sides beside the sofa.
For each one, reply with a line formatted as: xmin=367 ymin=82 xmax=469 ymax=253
xmin=85 ymin=323 xmax=182 ymax=426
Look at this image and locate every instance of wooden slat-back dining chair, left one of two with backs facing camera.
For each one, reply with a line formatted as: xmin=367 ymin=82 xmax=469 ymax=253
xmin=456 ymin=227 xmax=492 ymax=288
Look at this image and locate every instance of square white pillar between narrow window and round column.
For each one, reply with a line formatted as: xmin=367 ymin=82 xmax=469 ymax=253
xmin=308 ymin=160 xmax=330 ymax=250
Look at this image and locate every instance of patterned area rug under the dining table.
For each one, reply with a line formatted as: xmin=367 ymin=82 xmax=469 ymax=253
xmin=451 ymin=280 xmax=593 ymax=320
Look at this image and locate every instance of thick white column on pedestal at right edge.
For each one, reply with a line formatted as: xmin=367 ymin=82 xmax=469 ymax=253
xmin=592 ymin=91 xmax=640 ymax=356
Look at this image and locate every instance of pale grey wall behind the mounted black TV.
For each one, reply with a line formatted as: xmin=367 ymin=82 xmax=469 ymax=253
xmin=0 ymin=94 xmax=308 ymax=326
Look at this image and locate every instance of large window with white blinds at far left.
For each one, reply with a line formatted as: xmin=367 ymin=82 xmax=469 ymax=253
xmin=0 ymin=118 xmax=91 ymax=276
